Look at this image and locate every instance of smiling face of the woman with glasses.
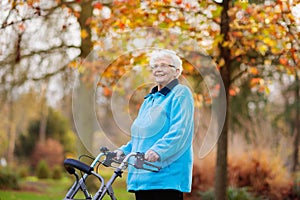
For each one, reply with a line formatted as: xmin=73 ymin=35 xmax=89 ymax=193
xmin=151 ymin=58 xmax=179 ymax=88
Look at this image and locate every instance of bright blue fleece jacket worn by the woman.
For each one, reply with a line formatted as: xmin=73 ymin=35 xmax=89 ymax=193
xmin=120 ymin=79 xmax=194 ymax=192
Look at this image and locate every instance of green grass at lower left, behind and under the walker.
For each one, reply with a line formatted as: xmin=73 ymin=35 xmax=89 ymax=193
xmin=0 ymin=170 xmax=134 ymax=200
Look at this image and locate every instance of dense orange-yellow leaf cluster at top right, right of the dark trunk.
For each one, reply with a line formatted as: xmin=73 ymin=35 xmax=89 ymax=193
xmin=227 ymin=1 xmax=299 ymax=75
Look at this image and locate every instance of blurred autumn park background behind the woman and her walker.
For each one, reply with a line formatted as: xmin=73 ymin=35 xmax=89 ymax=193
xmin=0 ymin=0 xmax=300 ymax=200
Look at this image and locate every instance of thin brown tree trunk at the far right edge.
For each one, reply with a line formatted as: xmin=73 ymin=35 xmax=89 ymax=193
xmin=292 ymin=72 xmax=300 ymax=172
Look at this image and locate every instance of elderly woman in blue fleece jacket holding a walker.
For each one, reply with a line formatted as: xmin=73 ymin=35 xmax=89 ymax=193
xmin=116 ymin=50 xmax=194 ymax=200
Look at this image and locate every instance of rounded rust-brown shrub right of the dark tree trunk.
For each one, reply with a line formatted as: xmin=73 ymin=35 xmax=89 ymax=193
xmin=228 ymin=150 xmax=292 ymax=199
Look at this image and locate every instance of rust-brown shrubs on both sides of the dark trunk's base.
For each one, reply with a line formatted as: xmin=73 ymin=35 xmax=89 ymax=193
xmin=190 ymin=150 xmax=292 ymax=200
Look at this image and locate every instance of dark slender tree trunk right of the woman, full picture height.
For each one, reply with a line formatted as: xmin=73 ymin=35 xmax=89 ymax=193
xmin=215 ymin=0 xmax=231 ymax=200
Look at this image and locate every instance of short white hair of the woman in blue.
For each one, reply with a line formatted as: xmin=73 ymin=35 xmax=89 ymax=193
xmin=150 ymin=49 xmax=183 ymax=78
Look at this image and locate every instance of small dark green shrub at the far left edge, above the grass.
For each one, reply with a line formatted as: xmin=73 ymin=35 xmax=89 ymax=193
xmin=0 ymin=169 xmax=20 ymax=189
